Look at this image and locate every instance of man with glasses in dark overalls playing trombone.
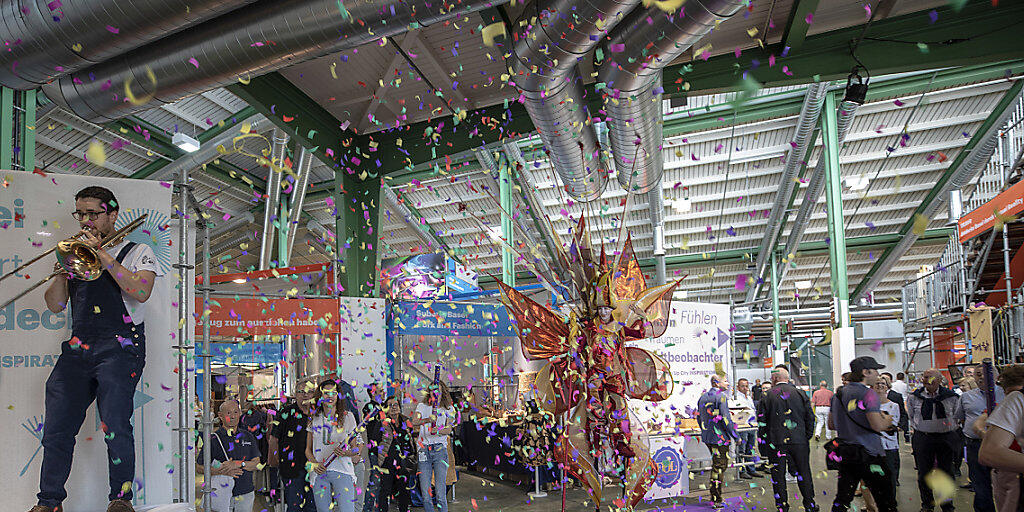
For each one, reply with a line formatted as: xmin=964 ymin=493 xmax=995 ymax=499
xmin=30 ymin=186 xmax=159 ymax=512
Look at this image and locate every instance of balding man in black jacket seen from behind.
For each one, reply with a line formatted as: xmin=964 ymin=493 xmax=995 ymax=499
xmin=758 ymin=368 xmax=818 ymax=512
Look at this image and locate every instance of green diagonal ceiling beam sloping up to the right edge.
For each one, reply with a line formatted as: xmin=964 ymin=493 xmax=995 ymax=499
xmin=850 ymin=80 xmax=1024 ymax=300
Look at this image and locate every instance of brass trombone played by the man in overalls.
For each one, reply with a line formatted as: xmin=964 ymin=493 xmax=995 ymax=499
xmin=0 ymin=213 xmax=150 ymax=309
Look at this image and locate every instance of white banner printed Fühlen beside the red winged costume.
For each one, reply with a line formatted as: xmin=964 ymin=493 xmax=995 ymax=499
xmin=630 ymin=302 xmax=732 ymax=429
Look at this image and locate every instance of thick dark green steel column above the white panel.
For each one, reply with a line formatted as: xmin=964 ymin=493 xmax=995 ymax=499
xmin=334 ymin=175 xmax=381 ymax=297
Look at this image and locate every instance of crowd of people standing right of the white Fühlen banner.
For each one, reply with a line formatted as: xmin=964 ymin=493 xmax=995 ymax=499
xmin=697 ymin=356 xmax=1024 ymax=512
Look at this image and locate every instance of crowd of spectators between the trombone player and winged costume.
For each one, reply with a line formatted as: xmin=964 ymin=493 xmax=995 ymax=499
xmin=196 ymin=379 xmax=460 ymax=512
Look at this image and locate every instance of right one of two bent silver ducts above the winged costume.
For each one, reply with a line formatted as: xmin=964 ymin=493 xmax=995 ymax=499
xmin=597 ymin=0 xmax=748 ymax=194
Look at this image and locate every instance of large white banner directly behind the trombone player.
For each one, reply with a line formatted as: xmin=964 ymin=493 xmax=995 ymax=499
xmin=0 ymin=171 xmax=179 ymax=512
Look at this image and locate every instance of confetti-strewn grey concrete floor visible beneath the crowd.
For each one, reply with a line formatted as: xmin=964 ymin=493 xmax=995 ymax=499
xmin=449 ymin=440 xmax=974 ymax=512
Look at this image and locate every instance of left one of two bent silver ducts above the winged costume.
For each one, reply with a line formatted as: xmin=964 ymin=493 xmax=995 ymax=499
xmin=507 ymin=0 xmax=639 ymax=201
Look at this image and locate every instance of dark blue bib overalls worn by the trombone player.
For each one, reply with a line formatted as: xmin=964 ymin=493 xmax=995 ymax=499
xmin=37 ymin=242 xmax=145 ymax=507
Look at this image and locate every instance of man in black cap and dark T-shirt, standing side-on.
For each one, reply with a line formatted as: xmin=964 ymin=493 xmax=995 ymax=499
xmin=828 ymin=355 xmax=896 ymax=512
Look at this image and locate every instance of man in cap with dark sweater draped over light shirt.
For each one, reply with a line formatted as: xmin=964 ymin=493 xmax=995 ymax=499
xmin=906 ymin=368 xmax=964 ymax=512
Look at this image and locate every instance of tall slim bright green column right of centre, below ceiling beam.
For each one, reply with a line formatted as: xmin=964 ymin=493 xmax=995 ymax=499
xmin=821 ymin=91 xmax=850 ymax=328
